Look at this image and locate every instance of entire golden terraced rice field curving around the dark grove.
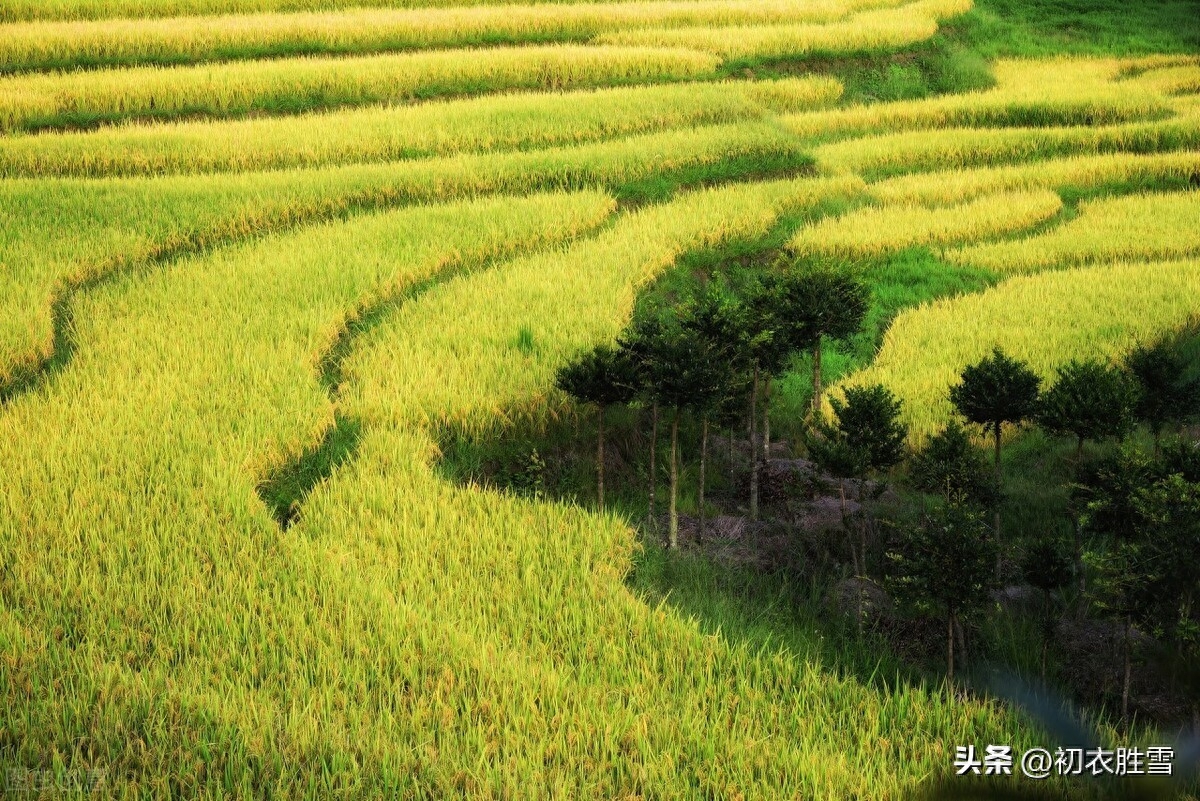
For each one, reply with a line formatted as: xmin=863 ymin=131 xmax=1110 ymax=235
xmin=0 ymin=0 xmax=1200 ymax=799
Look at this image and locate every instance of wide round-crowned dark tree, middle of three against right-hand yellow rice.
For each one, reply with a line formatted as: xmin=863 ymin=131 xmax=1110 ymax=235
xmin=1034 ymin=360 xmax=1136 ymax=464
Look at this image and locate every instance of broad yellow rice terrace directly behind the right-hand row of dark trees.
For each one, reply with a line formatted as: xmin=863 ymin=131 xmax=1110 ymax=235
xmin=846 ymin=260 xmax=1200 ymax=440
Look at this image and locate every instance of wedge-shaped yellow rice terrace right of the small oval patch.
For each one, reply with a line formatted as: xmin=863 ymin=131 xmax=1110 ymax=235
xmin=943 ymin=192 xmax=1200 ymax=272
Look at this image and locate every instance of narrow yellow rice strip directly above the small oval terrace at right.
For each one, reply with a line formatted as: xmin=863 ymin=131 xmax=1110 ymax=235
xmin=870 ymin=150 xmax=1200 ymax=205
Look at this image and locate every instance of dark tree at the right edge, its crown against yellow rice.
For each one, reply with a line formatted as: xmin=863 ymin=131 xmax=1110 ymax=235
xmin=1124 ymin=338 xmax=1200 ymax=454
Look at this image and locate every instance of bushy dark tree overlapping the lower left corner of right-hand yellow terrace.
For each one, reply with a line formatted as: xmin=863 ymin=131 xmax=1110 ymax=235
xmin=806 ymin=384 xmax=908 ymax=576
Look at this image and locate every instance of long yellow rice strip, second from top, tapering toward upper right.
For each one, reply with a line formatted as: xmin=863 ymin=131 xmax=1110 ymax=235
xmin=0 ymin=0 xmax=901 ymax=72
